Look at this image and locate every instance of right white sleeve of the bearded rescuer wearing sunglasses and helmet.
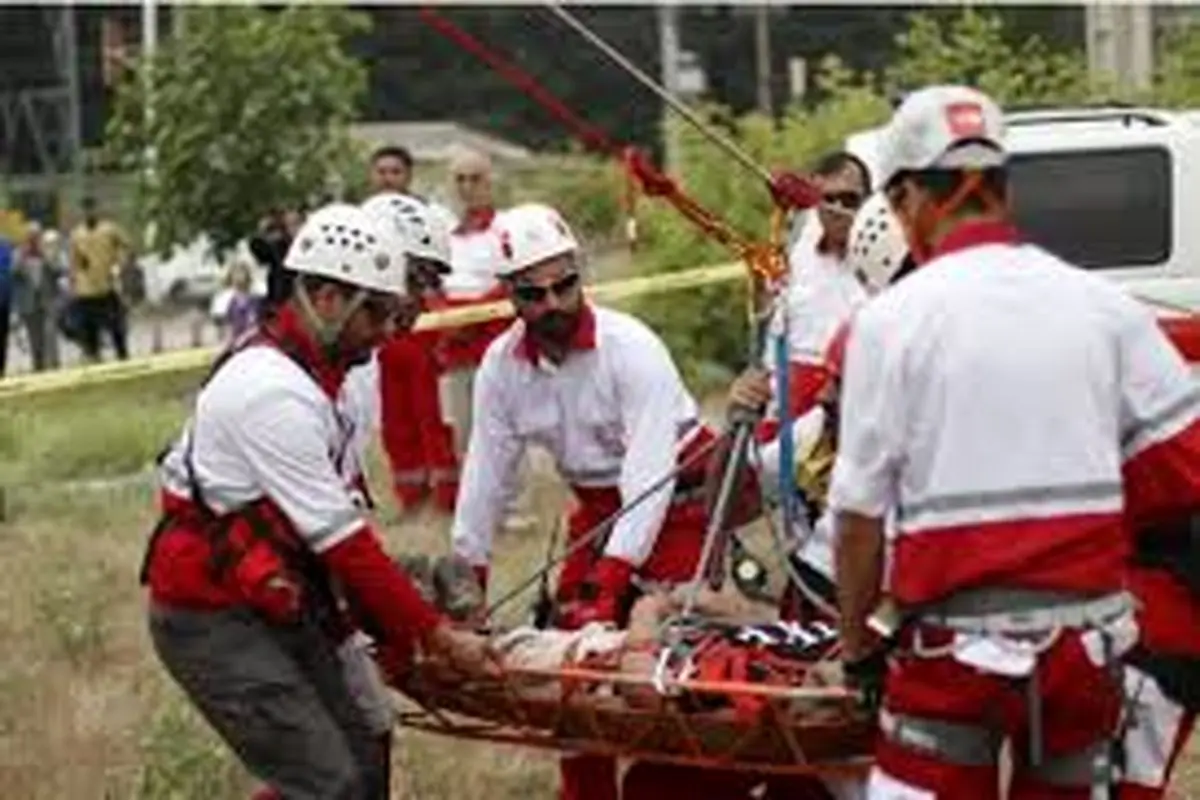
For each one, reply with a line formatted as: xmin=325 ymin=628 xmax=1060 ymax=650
xmin=605 ymin=335 xmax=686 ymax=567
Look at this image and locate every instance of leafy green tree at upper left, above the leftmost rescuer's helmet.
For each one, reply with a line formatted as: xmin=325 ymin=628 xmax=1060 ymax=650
xmin=106 ymin=6 xmax=367 ymax=252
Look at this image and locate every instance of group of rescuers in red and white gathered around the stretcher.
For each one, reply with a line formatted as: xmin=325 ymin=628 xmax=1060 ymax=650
xmin=136 ymin=86 xmax=1200 ymax=800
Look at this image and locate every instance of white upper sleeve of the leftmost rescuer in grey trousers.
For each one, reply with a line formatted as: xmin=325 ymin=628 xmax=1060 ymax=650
xmin=234 ymin=393 xmax=366 ymax=553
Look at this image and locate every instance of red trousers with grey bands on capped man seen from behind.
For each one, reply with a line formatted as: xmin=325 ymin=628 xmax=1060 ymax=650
xmin=868 ymin=632 xmax=1121 ymax=800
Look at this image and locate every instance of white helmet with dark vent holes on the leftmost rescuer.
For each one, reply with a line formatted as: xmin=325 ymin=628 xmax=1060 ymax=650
xmin=283 ymin=203 xmax=407 ymax=295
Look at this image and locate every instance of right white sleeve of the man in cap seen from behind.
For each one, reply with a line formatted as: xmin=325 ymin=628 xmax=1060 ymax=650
xmin=1120 ymin=299 xmax=1200 ymax=461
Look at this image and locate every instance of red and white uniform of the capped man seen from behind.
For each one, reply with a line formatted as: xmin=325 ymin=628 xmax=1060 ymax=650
xmin=830 ymin=223 xmax=1200 ymax=798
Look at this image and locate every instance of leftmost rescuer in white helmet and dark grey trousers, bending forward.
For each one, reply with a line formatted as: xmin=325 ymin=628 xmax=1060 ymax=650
xmin=142 ymin=204 xmax=487 ymax=800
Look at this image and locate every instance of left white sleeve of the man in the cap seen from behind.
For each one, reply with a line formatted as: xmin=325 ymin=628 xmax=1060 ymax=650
xmin=828 ymin=307 xmax=904 ymax=517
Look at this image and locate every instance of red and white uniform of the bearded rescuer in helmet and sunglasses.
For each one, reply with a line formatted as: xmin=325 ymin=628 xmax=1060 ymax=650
xmin=452 ymin=307 xmax=710 ymax=594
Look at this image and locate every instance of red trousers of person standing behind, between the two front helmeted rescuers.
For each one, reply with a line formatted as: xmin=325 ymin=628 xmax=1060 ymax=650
xmin=379 ymin=332 xmax=458 ymax=512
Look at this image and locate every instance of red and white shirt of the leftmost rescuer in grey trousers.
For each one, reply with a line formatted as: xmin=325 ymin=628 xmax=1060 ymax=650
xmin=146 ymin=308 xmax=437 ymax=648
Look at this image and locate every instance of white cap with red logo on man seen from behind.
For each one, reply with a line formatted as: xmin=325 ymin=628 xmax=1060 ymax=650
xmin=880 ymin=86 xmax=1008 ymax=186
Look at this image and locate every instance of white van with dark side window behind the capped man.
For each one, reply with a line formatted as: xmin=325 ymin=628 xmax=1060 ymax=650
xmin=846 ymin=107 xmax=1200 ymax=315
